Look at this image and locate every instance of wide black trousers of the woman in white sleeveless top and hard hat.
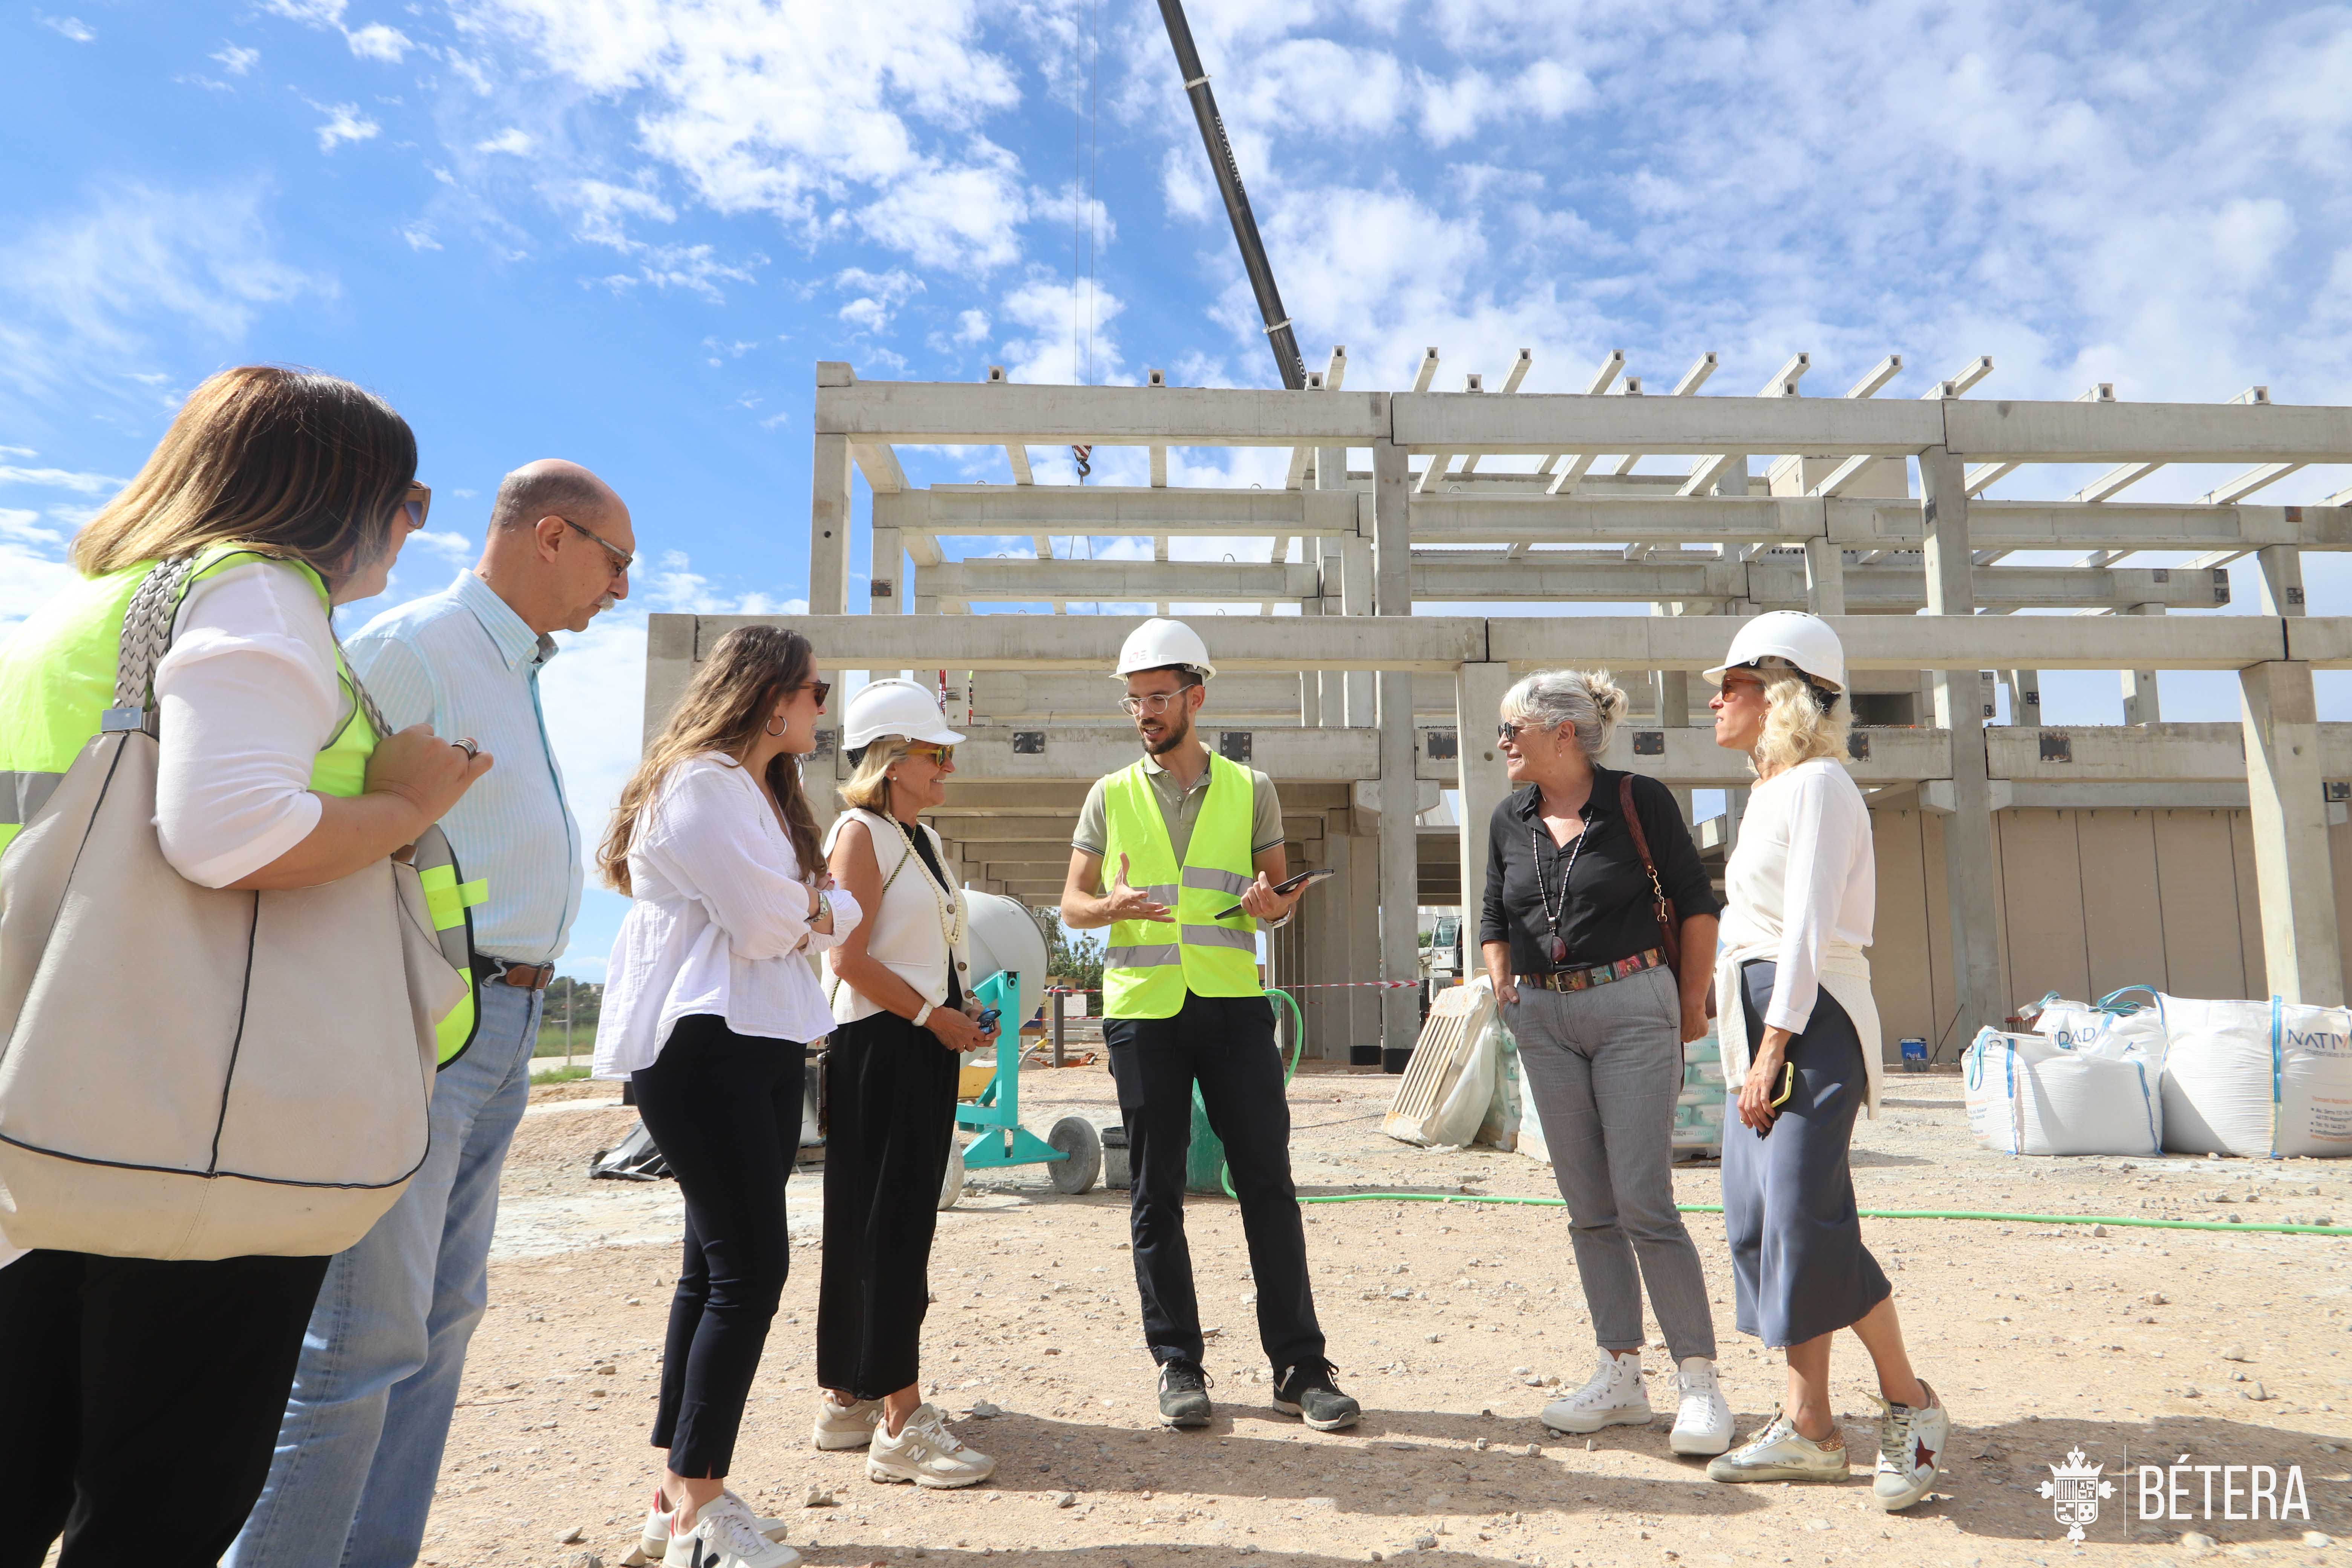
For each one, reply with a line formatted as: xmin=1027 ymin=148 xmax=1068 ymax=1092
xmin=816 ymin=1013 xmax=955 ymax=1399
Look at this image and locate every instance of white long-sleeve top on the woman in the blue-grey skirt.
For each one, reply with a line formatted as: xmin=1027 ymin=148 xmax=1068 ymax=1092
xmin=1717 ymin=757 xmax=1882 ymax=1117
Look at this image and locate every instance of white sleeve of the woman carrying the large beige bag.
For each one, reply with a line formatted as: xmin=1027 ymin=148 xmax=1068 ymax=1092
xmin=155 ymin=562 xmax=351 ymax=886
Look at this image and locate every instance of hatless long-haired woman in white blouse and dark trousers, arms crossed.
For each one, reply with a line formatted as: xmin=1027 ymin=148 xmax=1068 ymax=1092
xmin=595 ymin=625 xmax=859 ymax=1568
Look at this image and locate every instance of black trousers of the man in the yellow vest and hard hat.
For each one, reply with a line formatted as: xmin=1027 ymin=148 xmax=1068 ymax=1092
xmin=1103 ymin=992 xmax=1324 ymax=1375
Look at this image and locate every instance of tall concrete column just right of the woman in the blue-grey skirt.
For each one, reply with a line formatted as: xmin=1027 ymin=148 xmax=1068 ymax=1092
xmin=1919 ymin=447 xmax=2009 ymax=1049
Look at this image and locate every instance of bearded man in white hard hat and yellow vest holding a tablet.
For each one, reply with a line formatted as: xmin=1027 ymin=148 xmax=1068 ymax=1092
xmin=1061 ymin=621 xmax=1360 ymax=1432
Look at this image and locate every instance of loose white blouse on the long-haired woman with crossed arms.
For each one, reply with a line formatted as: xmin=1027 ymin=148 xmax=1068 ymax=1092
xmin=595 ymin=752 xmax=861 ymax=1079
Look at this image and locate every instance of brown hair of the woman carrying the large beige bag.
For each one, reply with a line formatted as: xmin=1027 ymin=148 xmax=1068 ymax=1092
xmin=73 ymin=364 xmax=416 ymax=576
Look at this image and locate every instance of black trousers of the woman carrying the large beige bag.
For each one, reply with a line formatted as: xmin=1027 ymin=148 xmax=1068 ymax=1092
xmin=0 ymin=1253 xmax=327 ymax=1568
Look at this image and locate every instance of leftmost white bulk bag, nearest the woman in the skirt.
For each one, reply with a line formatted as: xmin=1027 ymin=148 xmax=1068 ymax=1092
xmin=1962 ymin=1030 xmax=2164 ymax=1154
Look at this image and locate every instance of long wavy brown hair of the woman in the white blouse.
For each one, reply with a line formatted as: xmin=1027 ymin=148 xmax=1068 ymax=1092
xmin=597 ymin=625 xmax=821 ymax=893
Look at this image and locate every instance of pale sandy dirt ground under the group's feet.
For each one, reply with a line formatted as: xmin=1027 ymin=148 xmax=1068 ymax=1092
xmin=423 ymin=1065 xmax=2352 ymax=1568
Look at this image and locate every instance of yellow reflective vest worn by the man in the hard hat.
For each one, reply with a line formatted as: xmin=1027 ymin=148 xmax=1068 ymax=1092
xmin=1103 ymin=752 xmax=1263 ymax=1018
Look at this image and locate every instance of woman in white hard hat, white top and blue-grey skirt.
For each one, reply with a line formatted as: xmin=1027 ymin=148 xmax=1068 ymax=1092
xmin=1707 ymin=611 xmax=1952 ymax=1511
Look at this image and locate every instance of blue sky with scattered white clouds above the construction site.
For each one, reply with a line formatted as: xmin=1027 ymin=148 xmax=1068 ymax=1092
xmin=0 ymin=0 xmax=2352 ymax=973
